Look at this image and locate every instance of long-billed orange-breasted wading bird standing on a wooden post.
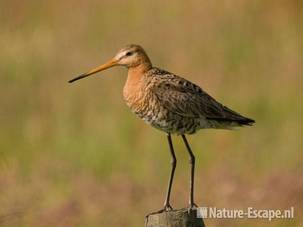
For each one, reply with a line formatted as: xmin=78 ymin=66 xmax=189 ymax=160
xmin=69 ymin=44 xmax=255 ymax=213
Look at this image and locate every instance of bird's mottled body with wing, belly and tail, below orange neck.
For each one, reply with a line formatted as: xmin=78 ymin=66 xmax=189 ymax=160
xmin=124 ymin=67 xmax=254 ymax=134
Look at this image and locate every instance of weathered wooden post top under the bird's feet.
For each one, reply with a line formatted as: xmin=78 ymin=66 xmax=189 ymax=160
xmin=145 ymin=208 xmax=205 ymax=227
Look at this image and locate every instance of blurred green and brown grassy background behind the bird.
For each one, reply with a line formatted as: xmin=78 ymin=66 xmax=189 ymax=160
xmin=0 ymin=0 xmax=303 ymax=227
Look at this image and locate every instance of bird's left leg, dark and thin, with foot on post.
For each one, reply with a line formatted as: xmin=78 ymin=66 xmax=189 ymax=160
xmin=146 ymin=133 xmax=177 ymax=218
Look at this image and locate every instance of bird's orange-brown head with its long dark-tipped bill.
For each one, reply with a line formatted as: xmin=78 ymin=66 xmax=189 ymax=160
xmin=68 ymin=44 xmax=151 ymax=83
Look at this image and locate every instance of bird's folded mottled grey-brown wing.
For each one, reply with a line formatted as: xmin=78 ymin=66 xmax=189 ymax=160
xmin=153 ymin=75 xmax=252 ymax=121
